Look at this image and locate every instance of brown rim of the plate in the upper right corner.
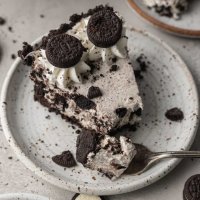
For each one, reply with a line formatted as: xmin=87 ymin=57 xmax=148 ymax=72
xmin=127 ymin=0 xmax=200 ymax=38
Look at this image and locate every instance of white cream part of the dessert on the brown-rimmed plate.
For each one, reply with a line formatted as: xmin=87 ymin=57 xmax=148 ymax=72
xmin=143 ymin=0 xmax=188 ymax=19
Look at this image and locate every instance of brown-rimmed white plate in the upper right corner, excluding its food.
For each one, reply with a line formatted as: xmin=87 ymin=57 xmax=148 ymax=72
xmin=128 ymin=0 xmax=200 ymax=38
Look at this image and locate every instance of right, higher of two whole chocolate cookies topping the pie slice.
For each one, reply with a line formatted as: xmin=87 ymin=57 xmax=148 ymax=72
xmin=87 ymin=10 xmax=122 ymax=48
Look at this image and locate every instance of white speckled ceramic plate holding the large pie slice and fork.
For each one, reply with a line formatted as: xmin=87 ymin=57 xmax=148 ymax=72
xmin=1 ymin=29 xmax=198 ymax=195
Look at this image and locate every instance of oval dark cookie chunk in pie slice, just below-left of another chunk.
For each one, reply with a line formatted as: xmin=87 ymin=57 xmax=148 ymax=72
xmin=74 ymin=95 xmax=96 ymax=110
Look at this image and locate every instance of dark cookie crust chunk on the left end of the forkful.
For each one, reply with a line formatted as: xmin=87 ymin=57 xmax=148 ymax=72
xmin=76 ymin=131 xmax=98 ymax=165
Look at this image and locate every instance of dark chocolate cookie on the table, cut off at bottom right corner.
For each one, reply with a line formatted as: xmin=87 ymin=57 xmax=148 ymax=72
xmin=183 ymin=174 xmax=200 ymax=200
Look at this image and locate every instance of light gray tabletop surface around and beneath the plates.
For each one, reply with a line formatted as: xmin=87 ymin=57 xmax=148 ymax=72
xmin=0 ymin=0 xmax=200 ymax=200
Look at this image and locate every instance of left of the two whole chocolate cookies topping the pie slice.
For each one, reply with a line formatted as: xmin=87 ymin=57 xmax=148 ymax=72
xmin=46 ymin=34 xmax=84 ymax=68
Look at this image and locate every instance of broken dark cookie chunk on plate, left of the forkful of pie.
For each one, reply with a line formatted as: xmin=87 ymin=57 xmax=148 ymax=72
xmin=52 ymin=151 xmax=76 ymax=167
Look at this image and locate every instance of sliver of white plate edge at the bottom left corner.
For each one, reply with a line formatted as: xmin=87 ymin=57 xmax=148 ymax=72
xmin=0 ymin=193 xmax=49 ymax=200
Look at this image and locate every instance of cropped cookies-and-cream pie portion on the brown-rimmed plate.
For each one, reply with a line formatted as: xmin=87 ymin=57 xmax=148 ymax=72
xmin=143 ymin=0 xmax=188 ymax=19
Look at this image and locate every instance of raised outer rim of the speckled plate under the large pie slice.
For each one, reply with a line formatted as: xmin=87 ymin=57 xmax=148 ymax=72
xmin=0 ymin=27 xmax=199 ymax=195
